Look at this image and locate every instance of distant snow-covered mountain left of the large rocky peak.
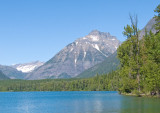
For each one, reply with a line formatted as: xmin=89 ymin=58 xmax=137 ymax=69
xmin=11 ymin=61 xmax=44 ymax=73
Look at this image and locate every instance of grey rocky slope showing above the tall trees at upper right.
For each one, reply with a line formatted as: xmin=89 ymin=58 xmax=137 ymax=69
xmin=139 ymin=18 xmax=157 ymax=39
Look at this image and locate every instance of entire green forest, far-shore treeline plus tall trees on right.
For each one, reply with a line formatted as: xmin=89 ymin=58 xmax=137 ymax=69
xmin=0 ymin=5 xmax=160 ymax=96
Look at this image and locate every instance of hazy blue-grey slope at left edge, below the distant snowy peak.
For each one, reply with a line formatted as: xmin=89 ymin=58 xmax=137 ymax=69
xmin=0 ymin=65 xmax=26 ymax=79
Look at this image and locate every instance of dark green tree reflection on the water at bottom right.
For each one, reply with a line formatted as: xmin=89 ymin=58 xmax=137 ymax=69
xmin=121 ymin=96 xmax=160 ymax=113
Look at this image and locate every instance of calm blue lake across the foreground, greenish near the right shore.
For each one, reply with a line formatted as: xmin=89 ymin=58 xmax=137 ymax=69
xmin=0 ymin=91 xmax=160 ymax=113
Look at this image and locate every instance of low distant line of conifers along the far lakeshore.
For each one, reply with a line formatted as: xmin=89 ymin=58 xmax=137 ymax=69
xmin=0 ymin=72 xmax=118 ymax=91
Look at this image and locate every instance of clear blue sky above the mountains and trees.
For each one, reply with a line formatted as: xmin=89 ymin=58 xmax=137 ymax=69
xmin=0 ymin=0 xmax=160 ymax=65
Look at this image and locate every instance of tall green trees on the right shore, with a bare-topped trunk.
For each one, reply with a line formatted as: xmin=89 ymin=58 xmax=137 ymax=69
xmin=117 ymin=5 xmax=160 ymax=95
